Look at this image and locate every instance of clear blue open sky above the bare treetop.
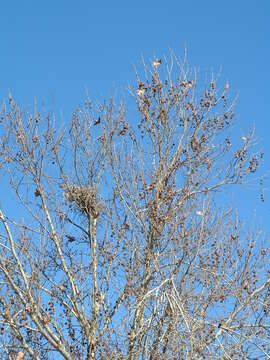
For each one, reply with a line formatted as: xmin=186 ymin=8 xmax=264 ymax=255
xmin=0 ymin=0 xmax=270 ymax=225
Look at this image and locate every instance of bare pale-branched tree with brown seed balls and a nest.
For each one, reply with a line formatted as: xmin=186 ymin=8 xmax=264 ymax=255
xmin=0 ymin=55 xmax=270 ymax=360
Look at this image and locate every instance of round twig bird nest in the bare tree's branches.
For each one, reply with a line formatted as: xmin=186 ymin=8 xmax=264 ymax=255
xmin=64 ymin=185 xmax=101 ymax=218
